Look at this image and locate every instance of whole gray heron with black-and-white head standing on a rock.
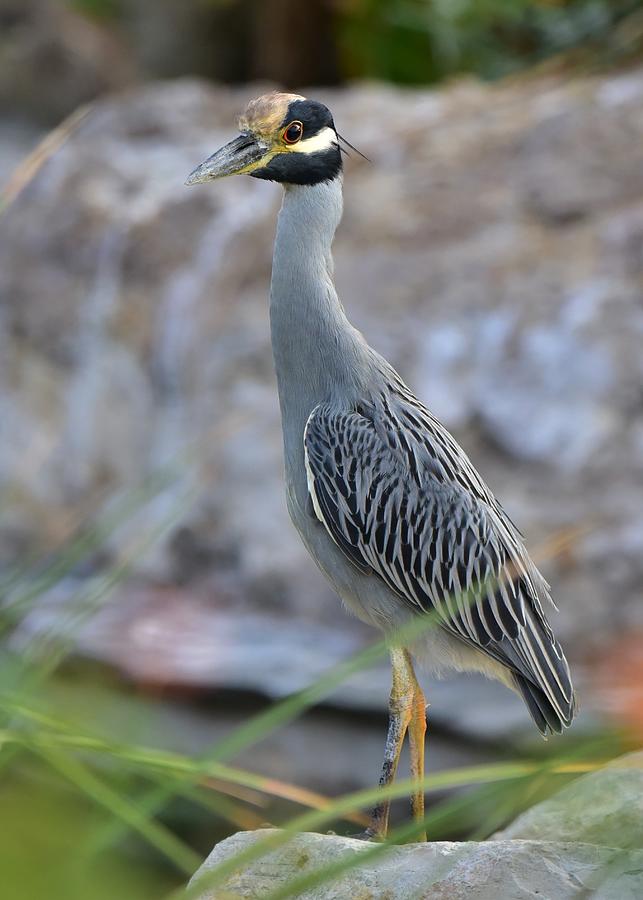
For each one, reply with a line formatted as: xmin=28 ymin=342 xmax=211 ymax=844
xmin=187 ymin=91 xmax=576 ymax=840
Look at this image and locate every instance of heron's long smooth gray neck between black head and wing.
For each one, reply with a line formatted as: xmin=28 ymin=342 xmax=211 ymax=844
xmin=270 ymin=178 xmax=366 ymax=426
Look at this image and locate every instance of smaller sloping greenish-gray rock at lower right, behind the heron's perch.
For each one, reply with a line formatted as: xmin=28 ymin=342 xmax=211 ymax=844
xmin=496 ymin=752 xmax=643 ymax=848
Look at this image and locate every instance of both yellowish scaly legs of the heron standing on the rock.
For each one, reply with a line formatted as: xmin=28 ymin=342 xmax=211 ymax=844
xmin=358 ymin=648 xmax=426 ymax=841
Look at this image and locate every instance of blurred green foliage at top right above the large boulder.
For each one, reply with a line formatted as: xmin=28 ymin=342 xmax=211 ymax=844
xmin=338 ymin=0 xmax=641 ymax=84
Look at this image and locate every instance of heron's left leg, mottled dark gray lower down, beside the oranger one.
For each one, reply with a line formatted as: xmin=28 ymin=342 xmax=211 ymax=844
xmin=363 ymin=647 xmax=419 ymax=841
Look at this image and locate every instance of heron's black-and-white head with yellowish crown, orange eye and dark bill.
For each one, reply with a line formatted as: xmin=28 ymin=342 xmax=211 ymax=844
xmin=186 ymin=91 xmax=342 ymax=184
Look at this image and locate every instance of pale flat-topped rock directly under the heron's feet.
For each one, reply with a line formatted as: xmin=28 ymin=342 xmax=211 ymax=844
xmin=191 ymin=829 xmax=643 ymax=900
